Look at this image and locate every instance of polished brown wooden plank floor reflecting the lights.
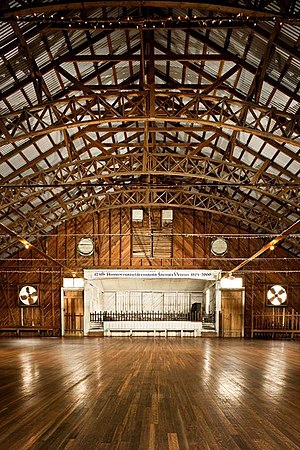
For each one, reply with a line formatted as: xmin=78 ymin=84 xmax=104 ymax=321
xmin=0 ymin=338 xmax=300 ymax=450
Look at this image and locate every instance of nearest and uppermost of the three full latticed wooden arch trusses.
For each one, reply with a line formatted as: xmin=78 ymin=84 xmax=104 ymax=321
xmin=0 ymin=91 xmax=300 ymax=147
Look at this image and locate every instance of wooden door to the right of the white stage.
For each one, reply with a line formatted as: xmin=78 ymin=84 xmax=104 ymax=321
xmin=220 ymin=290 xmax=244 ymax=337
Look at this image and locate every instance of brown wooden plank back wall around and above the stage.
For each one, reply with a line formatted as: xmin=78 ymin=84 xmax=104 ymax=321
xmin=0 ymin=208 xmax=300 ymax=335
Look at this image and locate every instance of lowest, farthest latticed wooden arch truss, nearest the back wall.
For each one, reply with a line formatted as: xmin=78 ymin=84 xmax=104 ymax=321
xmin=0 ymin=183 xmax=290 ymax=236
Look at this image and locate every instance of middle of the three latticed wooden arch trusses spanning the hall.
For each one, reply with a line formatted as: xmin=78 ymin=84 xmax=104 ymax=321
xmin=0 ymin=154 xmax=299 ymax=211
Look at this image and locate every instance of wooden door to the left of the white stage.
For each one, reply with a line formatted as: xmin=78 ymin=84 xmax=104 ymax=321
xmin=64 ymin=290 xmax=83 ymax=336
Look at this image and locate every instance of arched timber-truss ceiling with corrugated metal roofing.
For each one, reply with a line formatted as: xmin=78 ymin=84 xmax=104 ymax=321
xmin=0 ymin=0 xmax=300 ymax=256
